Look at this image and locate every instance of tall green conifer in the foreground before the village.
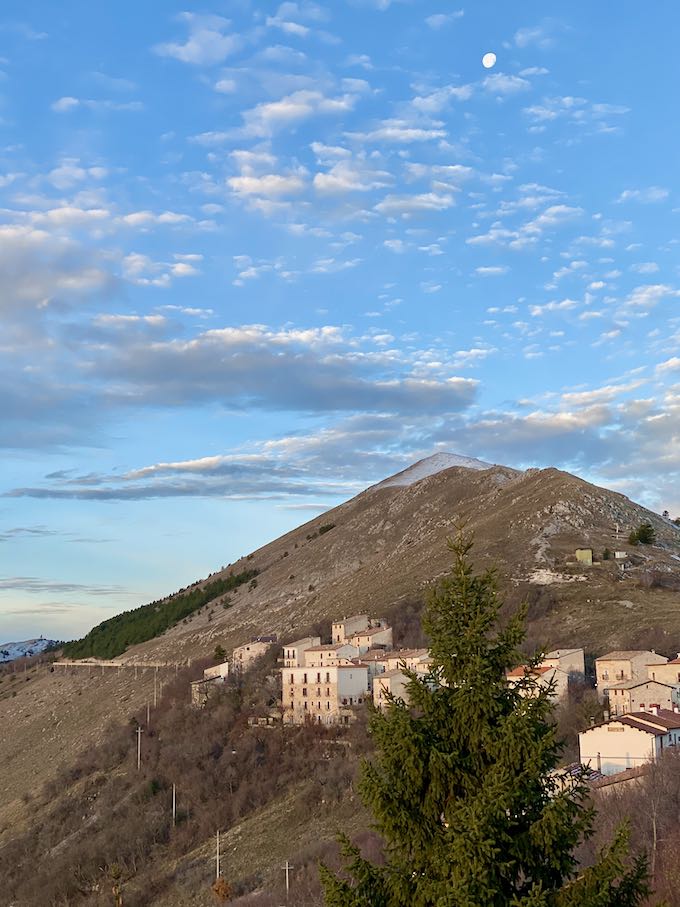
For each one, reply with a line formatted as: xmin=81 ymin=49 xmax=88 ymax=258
xmin=321 ymin=532 xmax=649 ymax=907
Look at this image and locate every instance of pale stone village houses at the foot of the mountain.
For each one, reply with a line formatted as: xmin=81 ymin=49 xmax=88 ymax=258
xmin=191 ymin=614 xmax=680 ymax=777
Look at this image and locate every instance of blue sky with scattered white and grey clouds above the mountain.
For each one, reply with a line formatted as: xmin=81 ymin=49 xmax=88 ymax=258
xmin=0 ymin=0 xmax=680 ymax=639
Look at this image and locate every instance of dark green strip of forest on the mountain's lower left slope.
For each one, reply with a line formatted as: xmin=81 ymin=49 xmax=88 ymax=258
xmin=64 ymin=570 xmax=257 ymax=658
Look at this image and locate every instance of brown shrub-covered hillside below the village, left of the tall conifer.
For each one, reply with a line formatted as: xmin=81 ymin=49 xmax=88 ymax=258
xmin=0 ymin=650 xmax=367 ymax=907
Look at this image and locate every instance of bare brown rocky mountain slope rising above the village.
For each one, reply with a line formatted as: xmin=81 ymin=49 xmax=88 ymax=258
xmin=118 ymin=461 xmax=680 ymax=660
